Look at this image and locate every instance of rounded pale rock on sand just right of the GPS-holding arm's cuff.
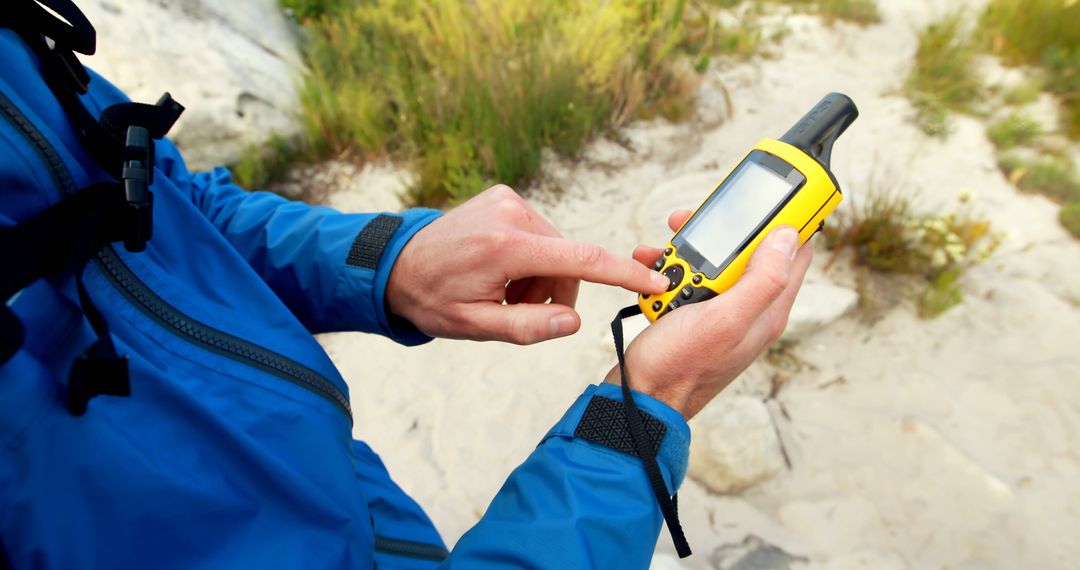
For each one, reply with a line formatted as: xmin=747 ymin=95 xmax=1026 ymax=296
xmin=688 ymin=395 xmax=784 ymax=493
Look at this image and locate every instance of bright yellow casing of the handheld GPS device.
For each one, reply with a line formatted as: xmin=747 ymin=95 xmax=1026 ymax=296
xmin=637 ymin=138 xmax=843 ymax=321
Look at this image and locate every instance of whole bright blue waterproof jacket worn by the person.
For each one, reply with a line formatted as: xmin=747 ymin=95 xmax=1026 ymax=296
xmin=0 ymin=29 xmax=689 ymax=570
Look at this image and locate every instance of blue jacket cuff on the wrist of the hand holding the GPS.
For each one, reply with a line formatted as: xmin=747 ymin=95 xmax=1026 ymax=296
xmin=541 ymin=383 xmax=690 ymax=494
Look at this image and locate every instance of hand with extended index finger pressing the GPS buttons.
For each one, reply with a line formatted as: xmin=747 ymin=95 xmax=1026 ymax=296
xmin=387 ymin=186 xmax=669 ymax=344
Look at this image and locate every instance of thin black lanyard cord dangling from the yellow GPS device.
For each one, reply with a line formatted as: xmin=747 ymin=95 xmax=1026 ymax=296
xmin=611 ymin=304 xmax=692 ymax=558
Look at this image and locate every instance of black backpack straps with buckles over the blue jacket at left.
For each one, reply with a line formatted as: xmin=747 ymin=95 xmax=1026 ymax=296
xmin=0 ymin=0 xmax=184 ymax=416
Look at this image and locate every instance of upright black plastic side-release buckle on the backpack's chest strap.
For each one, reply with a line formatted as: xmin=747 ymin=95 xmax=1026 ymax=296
xmin=120 ymin=125 xmax=153 ymax=253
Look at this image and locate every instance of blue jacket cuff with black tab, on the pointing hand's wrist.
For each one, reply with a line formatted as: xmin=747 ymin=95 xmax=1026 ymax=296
xmin=335 ymin=208 xmax=442 ymax=347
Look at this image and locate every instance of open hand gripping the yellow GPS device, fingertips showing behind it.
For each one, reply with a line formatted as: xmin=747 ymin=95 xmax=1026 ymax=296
xmin=605 ymin=211 xmax=813 ymax=420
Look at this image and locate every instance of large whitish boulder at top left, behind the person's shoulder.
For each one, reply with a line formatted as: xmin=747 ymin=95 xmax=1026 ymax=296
xmin=80 ymin=0 xmax=302 ymax=168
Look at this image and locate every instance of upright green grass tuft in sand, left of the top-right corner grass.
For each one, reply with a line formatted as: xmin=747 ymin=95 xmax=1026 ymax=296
xmin=904 ymin=12 xmax=983 ymax=136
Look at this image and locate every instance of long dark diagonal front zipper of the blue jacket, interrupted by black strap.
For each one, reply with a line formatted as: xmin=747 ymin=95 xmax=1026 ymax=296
xmin=0 ymin=87 xmax=352 ymax=423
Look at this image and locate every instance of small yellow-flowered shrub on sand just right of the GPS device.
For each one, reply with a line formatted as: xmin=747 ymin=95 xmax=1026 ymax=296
xmin=825 ymin=191 xmax=1000 ymax=317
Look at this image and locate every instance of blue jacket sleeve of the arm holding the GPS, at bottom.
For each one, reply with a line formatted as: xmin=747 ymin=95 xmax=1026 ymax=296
xmin=443 ymin=384 xmax=690 ymax=569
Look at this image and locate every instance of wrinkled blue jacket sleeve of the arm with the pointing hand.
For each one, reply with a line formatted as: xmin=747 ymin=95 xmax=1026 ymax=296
xmin=156 ymin=140 xmax=440 ymax=344
